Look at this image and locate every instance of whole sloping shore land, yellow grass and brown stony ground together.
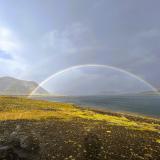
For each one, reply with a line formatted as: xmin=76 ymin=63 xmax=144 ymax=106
xmin=0 ymin=96 xmax=160 ymax=160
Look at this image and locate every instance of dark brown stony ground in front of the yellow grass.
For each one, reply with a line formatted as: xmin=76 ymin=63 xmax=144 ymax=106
xmin=0 ymin=119 xmax=160 ymax=160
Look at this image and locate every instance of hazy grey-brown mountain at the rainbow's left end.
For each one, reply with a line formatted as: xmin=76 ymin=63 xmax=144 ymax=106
xmin=0 ymin=77 xmax=48 ymax=95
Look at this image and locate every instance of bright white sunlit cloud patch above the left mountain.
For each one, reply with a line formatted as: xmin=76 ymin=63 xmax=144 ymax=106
xmin=0 ymin=27 xmax=26 ymax=78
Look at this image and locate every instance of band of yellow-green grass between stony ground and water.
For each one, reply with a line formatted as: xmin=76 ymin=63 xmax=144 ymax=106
xmin=0 ymin=97 xmax=160 ymax=132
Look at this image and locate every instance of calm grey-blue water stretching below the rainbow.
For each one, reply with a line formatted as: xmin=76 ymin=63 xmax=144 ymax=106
xmin=33 ymin=95 xmax=160 ymax=117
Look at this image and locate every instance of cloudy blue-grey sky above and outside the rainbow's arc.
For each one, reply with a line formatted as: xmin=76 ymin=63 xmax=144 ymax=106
xmin=0 ymin=0 xmax=160 ymax=94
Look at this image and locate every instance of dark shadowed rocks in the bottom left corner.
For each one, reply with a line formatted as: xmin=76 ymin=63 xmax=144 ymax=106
xmin=0 ymin=128 xmax=40 ymax=160
